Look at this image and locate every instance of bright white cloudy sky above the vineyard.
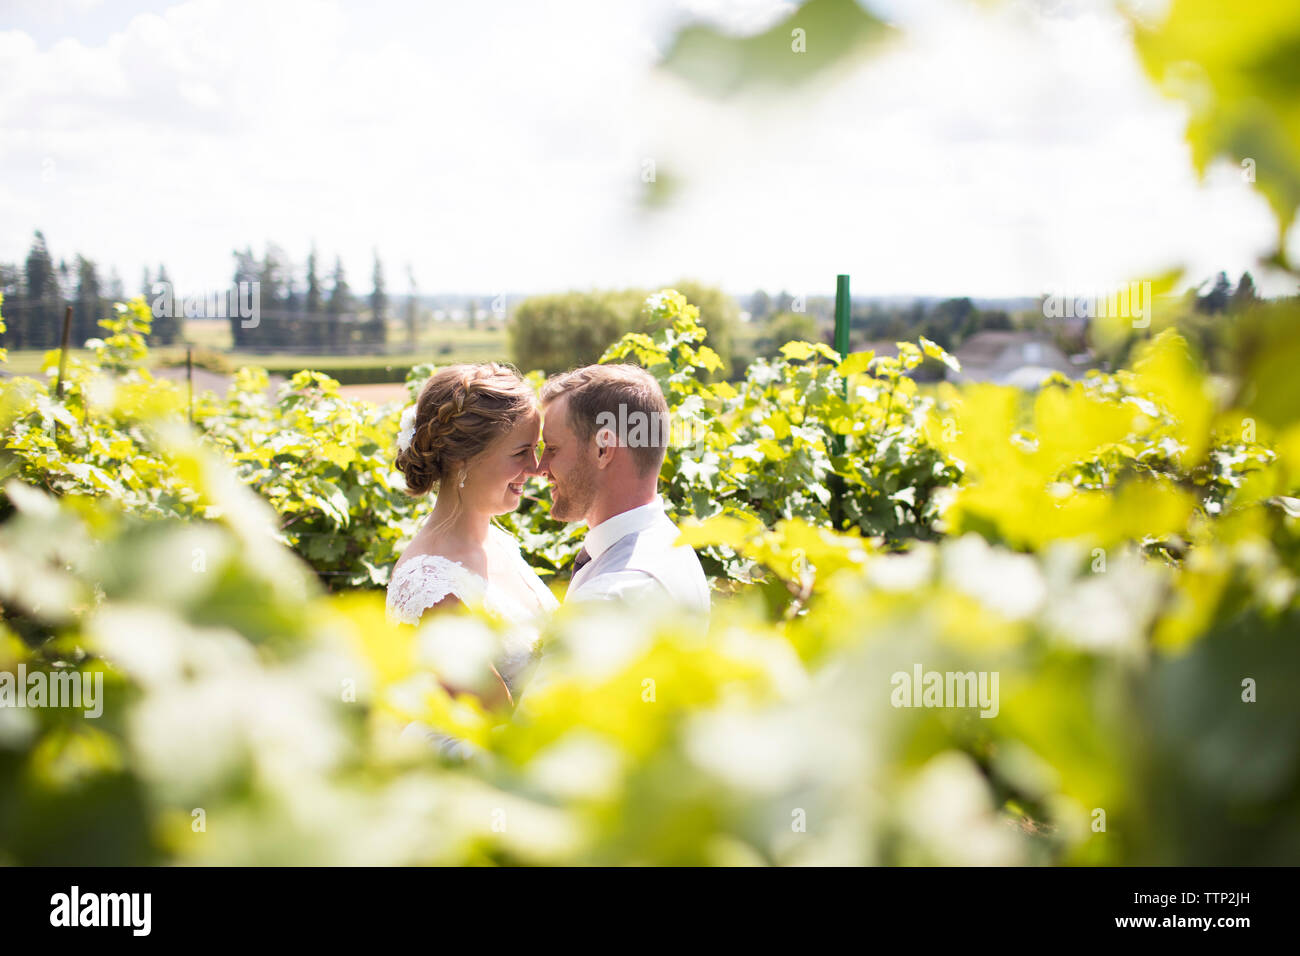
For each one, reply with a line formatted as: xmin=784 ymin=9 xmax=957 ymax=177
xmin=0 ymin=0 xmax=1297 ymax=295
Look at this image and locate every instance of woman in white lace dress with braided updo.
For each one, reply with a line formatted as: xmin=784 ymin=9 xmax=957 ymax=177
xmin=387 ymin=363 xmax=559 ymax=753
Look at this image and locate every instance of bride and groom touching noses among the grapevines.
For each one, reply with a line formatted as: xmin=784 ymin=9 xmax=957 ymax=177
xmin=387 ymin=363 xmax=709 ymax=723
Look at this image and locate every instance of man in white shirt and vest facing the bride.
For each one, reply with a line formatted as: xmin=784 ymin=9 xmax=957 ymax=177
xmin=537 ymin=365 xmax=709 ymax=615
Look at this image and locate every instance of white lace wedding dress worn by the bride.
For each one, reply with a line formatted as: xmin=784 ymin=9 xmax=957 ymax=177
xmin=386 ymin=524 xmax=560 ymax=757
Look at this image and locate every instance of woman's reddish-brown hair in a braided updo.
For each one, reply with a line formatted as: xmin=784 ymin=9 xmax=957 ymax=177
xmin=395 ymin=362 xmax=537 ymax=498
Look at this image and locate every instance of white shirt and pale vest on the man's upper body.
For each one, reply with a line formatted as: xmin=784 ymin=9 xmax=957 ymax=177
xmin=564 ymin=494 xmax=709 ymax=614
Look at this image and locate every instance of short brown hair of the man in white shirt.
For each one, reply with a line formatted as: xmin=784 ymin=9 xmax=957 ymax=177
xmin=542 ymin=365 xmax=670 ymax=475
